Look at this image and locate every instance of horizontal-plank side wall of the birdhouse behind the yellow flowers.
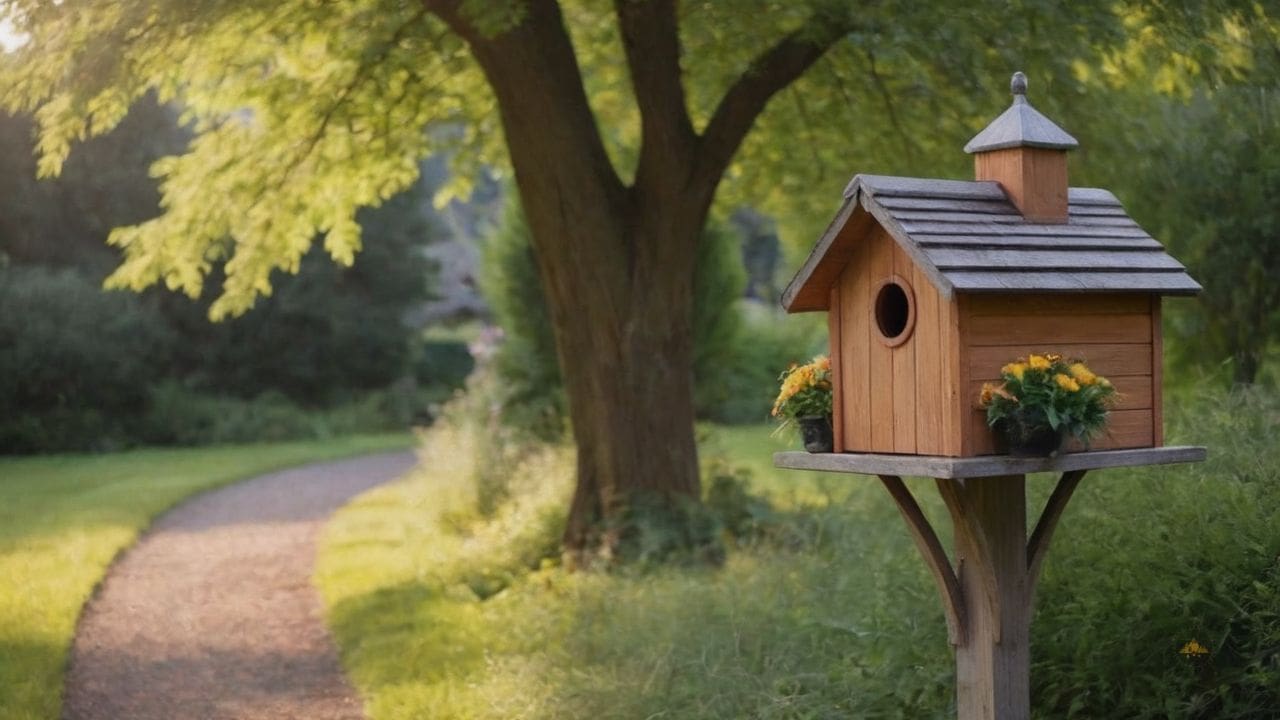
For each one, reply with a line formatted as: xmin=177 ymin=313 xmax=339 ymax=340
xmin=957 ymin=295 xmax=1161 ymax=456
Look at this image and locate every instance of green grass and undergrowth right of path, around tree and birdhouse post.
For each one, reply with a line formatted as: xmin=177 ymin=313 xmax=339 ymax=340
xmin=316 ymin=395 xmax=1280 ymax=720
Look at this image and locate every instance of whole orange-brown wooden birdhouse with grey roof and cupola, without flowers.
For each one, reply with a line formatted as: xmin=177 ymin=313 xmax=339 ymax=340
xmin=782 ymin=73 xmax=1201 ymax=457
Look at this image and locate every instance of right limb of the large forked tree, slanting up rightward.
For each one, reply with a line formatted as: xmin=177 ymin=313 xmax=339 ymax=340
xmin=694 ymin=14 xmax=851 ymax=192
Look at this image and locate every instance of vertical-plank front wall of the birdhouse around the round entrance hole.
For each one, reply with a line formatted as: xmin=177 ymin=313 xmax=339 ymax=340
xmin=833 ymin=228 xmax=959 ymax=455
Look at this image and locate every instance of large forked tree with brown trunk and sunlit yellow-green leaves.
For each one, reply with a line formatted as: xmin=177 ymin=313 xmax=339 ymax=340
xmin=0 ymin=0 xmax=1262 ymax=548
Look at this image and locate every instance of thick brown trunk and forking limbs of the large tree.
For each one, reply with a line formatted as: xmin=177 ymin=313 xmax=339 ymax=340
xmin=424 ymin=0 xmax=844 ymax=555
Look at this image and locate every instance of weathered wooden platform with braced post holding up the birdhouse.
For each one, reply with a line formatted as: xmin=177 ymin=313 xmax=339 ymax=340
xmin=773 ymin=446 xmax=1207 ymax=720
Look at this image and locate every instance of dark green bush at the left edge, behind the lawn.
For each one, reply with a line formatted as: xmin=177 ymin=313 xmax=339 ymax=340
xmin=0 ymin=266 xmax=172 ymax=454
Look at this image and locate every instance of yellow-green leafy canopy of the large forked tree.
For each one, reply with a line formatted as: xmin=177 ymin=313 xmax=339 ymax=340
xmin=0 ymin=0 xmax=1262 ymax=316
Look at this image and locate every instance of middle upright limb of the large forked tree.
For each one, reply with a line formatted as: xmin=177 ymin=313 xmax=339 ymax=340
xmin=613 ymin=0 xmax=696 ymax=188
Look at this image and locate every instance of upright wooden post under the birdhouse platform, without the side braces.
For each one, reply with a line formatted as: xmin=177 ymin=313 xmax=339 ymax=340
xmin=938 ymin=475 xmax=1032 ymax=720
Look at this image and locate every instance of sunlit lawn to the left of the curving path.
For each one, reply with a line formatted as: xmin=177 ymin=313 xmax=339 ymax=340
xmin=0 ymin=433 xmax=412 ymax=720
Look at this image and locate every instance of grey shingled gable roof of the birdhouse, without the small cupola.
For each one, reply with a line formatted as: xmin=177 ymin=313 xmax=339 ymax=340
xmin=782 ymin=176 xmax=1201 ymax=313
